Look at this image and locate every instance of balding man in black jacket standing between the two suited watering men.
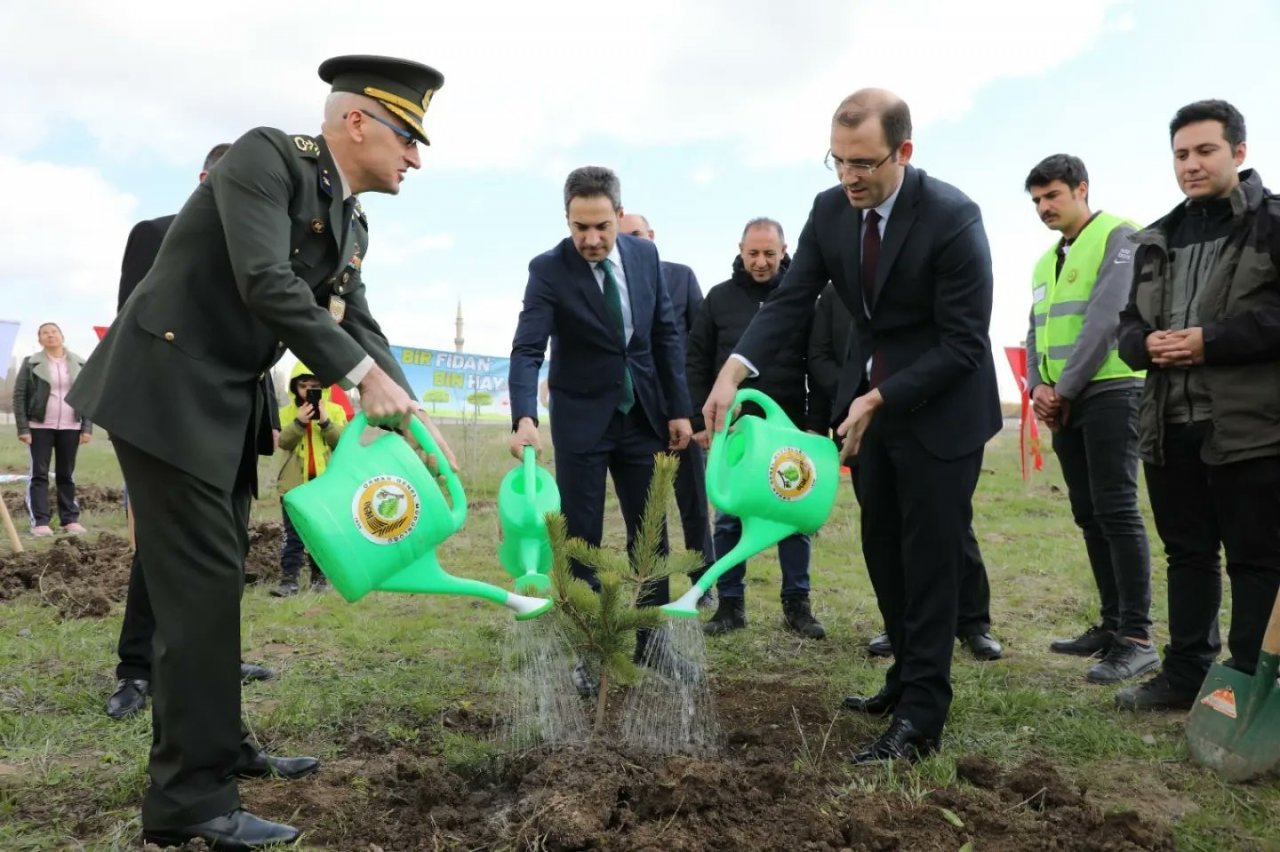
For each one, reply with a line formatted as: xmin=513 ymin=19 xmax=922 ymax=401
xmin=686 ymin=217 xmax=827 ymax=638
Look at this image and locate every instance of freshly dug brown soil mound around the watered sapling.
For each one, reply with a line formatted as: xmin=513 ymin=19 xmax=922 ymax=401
xmin=232 ymin=682 xmax=1174 ymax=852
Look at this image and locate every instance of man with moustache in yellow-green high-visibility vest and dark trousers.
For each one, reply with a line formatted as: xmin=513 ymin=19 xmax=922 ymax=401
xmin=1025 ymin=154 xmax=1160 ymax=683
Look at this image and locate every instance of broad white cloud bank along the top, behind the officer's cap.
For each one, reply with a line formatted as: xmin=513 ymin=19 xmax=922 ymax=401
xmin=0 ymin=0 xmax=1124 ymax=170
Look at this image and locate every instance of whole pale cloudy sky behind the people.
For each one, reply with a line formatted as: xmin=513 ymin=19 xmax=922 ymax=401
xmin=0 ymin=0 xmax=1280 ymax=398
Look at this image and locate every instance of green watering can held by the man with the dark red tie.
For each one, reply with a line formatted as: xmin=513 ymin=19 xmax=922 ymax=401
xmin=662 ymin=389 xmax=840 ymax=618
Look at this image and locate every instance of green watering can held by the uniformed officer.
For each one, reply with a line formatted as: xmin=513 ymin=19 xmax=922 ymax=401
xmin=284 ymin=412 xmax=552 ymax=620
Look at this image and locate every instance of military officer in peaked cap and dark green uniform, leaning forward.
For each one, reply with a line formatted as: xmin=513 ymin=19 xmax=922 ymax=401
xmin=69 ymin=56 xmax=453 ymax=849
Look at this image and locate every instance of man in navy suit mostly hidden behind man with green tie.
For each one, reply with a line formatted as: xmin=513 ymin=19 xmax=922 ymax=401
xmin=620 ymin=212 xmax=716 ymax=608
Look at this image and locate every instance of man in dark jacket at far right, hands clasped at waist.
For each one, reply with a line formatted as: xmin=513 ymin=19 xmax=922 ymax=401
xmin=1116 ymin=101 xmax=1280 ymax=710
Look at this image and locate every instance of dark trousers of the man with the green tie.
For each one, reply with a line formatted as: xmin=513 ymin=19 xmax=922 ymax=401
xmin=556 ymin=403 xmax=671 ymax=606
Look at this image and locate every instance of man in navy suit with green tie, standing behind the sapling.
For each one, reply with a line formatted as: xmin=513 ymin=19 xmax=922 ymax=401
xmin=508 ymin=166 xmax=692 ymax=691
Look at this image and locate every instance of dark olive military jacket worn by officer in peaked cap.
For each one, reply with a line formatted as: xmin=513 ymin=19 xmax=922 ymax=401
xmin=68 ymin=122 xmax=412 ymax=490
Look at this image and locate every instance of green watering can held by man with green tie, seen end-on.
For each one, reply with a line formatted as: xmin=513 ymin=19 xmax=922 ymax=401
xmin=498 ymin=446 xmax=559 ymax=594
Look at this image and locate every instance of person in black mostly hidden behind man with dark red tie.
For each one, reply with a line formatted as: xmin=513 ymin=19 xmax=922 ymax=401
xmin=808 ymin=284 xmax=1005 ymax=661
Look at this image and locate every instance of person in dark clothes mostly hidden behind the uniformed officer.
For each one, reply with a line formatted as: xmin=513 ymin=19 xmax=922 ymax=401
xmin=106 ymin=142 xmax=280 ymax=719
